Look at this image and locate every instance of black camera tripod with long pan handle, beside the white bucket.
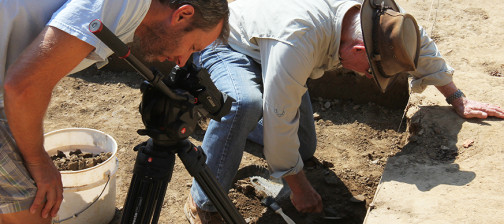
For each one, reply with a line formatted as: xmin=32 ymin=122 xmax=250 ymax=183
xmin=89 ymin=20 xmax=245 ymax=224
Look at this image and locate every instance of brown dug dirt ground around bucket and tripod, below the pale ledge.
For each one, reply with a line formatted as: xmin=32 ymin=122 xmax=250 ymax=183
xmin=45 ymin=69 xmax=406 ymax=223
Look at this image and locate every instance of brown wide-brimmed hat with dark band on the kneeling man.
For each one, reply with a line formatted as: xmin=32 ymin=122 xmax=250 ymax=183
xmin=361 ymin=0 xmax=420 ymax=92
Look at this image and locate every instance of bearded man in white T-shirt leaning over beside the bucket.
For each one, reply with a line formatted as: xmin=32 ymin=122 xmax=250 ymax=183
xmin=0 ymin=0 xmax=229 ymax=223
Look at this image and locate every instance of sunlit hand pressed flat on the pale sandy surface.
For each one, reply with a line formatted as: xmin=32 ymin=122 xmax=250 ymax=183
xmin=452 ymin=97 xmax=504 ymax=118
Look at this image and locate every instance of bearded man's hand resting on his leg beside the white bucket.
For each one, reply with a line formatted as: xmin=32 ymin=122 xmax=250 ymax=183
xmin=25 ymin=153 xmax=63 ymax=218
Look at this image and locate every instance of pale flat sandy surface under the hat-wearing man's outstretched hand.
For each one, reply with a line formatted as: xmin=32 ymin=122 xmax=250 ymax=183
xmin=365 ymin=0 xmax=504 ymax=224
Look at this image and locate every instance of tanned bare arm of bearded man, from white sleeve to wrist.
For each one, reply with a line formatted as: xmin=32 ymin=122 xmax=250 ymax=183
xmin=4 ymin=27 xmax=93 ymax=162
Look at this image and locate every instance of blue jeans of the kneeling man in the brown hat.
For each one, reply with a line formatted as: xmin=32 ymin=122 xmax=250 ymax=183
xmin=191 ymin=45 xmax=316 ymax=212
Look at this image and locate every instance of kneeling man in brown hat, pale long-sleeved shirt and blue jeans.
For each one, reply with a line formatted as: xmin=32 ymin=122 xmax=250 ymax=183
xmin=186 ymin=0 xmax=504 ymax=222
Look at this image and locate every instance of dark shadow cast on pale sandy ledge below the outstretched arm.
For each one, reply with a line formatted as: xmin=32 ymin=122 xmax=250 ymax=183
xmin=382 ymin=106 xmax=486 ymax=191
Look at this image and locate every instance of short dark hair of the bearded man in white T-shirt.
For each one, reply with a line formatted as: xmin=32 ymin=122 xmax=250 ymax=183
xmin=159 ymin=0 xmax=229 ymax=44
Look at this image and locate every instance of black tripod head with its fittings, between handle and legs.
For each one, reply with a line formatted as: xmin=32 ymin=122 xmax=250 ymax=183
xmin=138 ymin=63 xmax=234 ymax=143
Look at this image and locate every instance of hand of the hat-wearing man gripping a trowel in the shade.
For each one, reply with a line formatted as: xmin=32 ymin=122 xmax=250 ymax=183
xmin=284 ymin=171 xmax=323 ymax=213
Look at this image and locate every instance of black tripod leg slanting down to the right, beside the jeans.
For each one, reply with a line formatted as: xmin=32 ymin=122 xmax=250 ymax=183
xmin=178 ymin=141 xmax=245 ymax=224
